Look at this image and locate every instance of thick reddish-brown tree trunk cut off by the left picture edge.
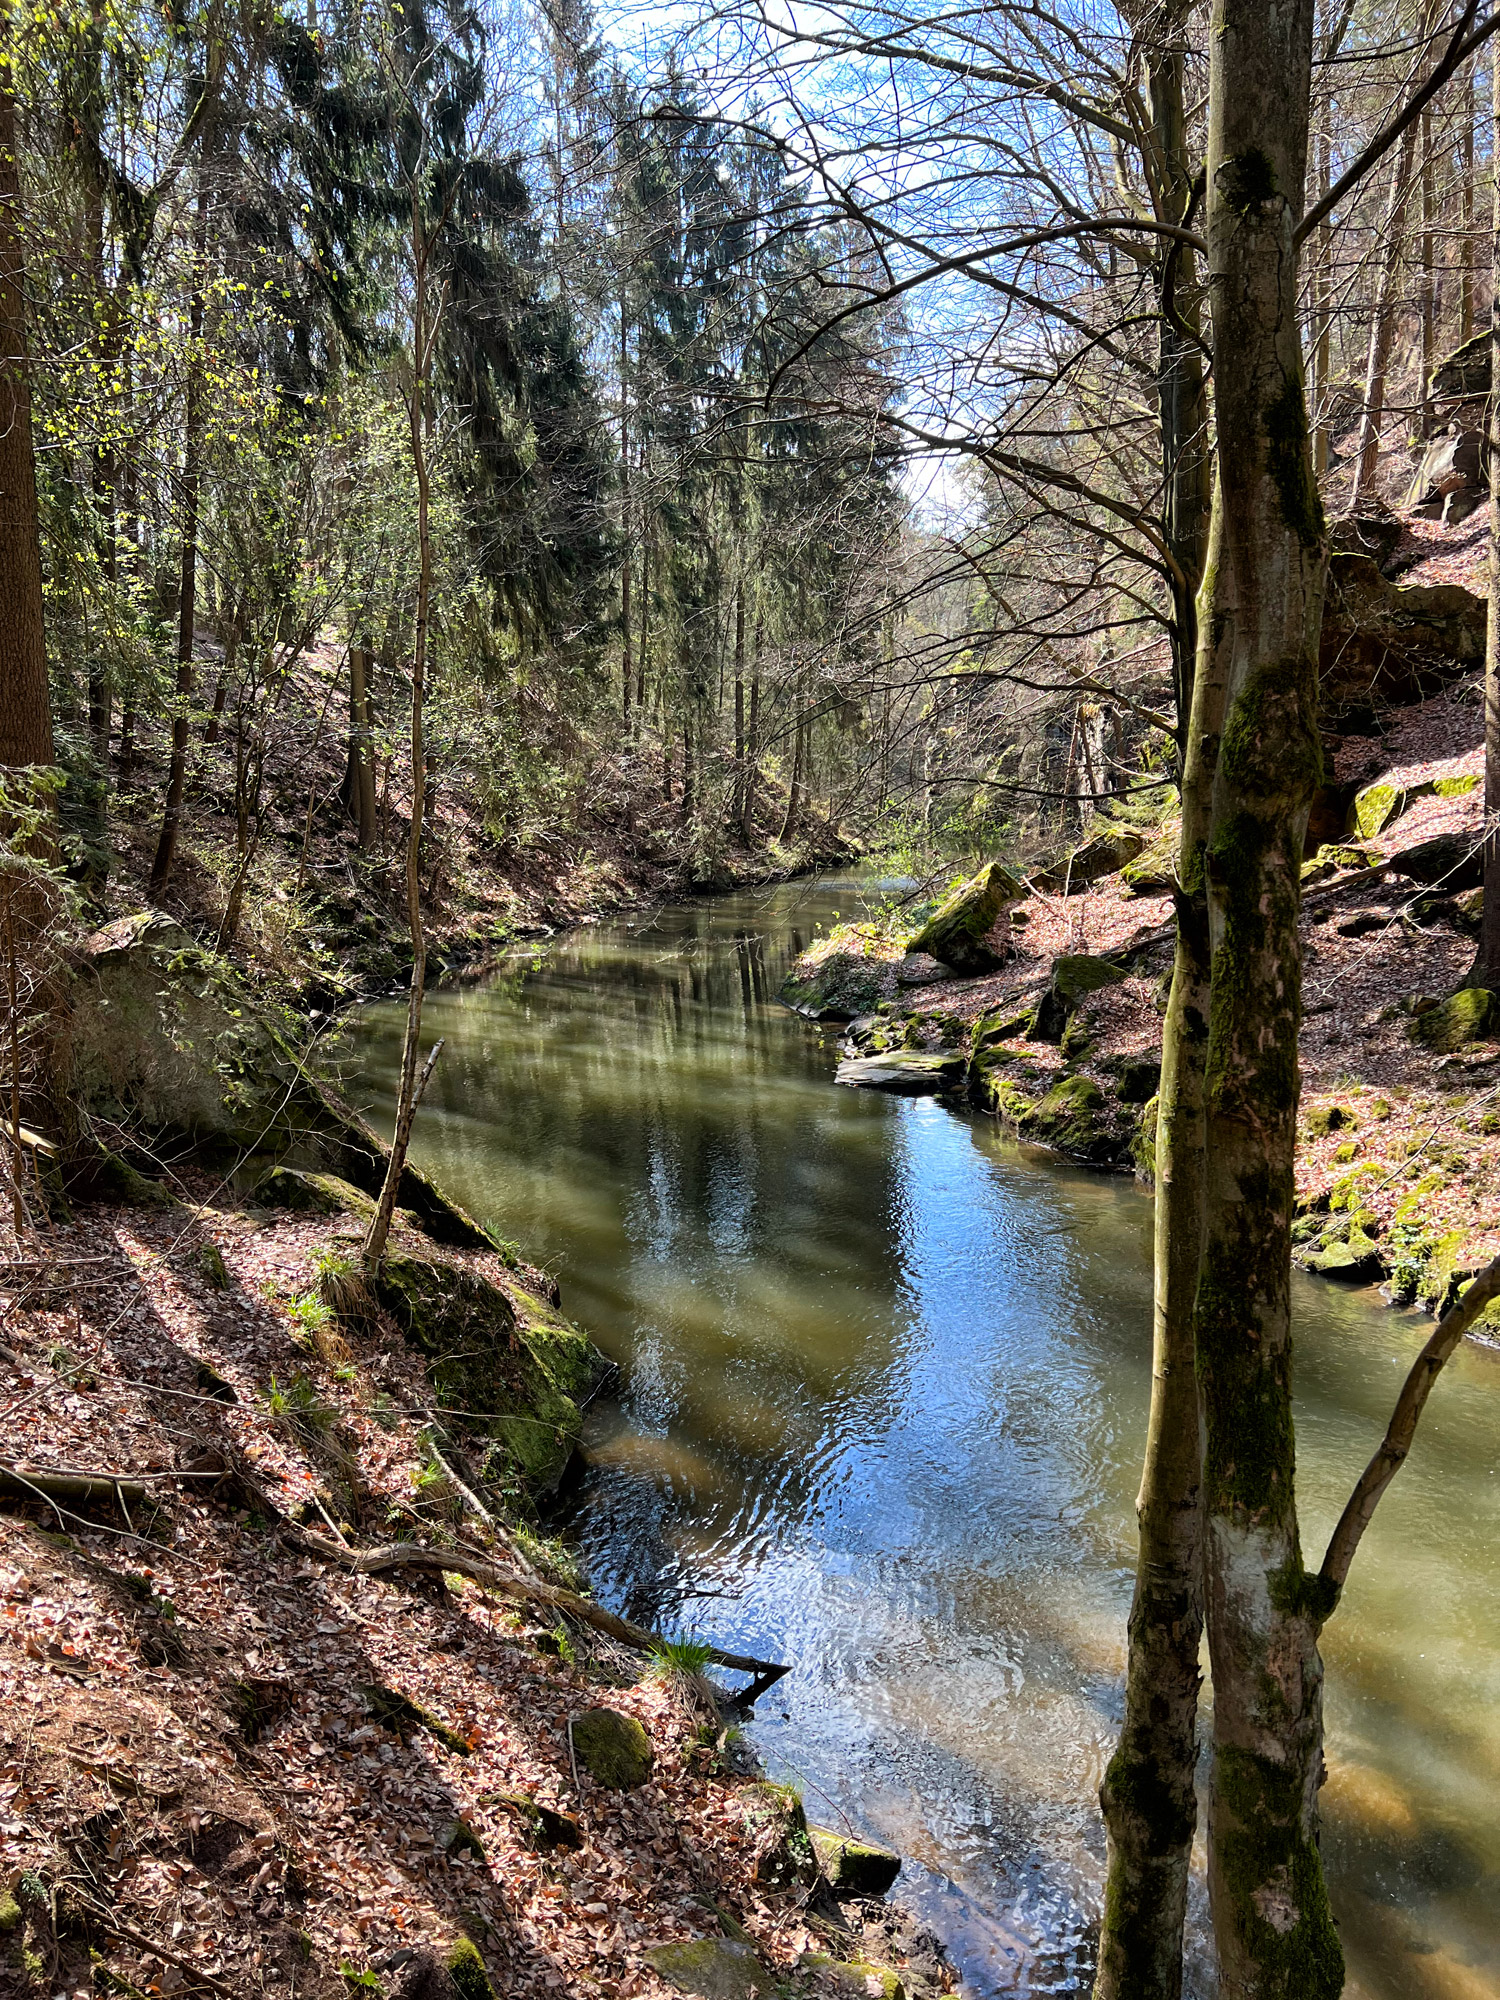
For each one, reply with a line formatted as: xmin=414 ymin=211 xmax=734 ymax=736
xmin=0 ymin=64 xmax=52 ymax=766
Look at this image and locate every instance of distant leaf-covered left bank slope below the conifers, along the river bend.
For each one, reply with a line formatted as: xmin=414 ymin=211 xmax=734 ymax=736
xmin=91 ymin=644 xmax=850 ymax=1012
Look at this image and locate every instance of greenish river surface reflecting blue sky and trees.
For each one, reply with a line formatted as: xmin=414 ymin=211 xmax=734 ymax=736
xmin=352 ymin=882 xmax=1500 ymax=2000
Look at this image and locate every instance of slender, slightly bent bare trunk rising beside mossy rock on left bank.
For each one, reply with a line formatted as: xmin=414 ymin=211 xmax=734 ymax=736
xmin=364 ymin=195 xmax=434 ymax=1264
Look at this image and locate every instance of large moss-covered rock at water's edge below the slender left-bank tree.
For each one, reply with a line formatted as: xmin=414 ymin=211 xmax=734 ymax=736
xmin=370 ymin=1240 xmax=608 ymax=1494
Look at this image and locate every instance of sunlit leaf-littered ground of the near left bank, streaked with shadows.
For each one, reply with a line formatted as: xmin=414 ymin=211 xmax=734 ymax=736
xmin=0 ymin=1178 xmax=944 ymax=2000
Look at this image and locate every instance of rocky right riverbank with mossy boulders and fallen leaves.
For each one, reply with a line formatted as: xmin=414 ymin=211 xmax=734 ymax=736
xmin=784 ymin=682 xmax=1500 ymax=1336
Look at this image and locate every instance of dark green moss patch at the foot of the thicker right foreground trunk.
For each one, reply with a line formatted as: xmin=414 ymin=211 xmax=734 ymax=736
xmin=1214 ymin=1746 xmax=1344 ymax=2000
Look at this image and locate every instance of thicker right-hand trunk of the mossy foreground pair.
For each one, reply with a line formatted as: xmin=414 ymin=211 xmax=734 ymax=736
xmin=1196 ymin=0 xmax=1344 ymax=2000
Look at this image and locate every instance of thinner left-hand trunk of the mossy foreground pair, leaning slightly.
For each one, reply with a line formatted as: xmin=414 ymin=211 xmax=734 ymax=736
xmin=1094 ymin=6 xmax=1222 ymax=2000
